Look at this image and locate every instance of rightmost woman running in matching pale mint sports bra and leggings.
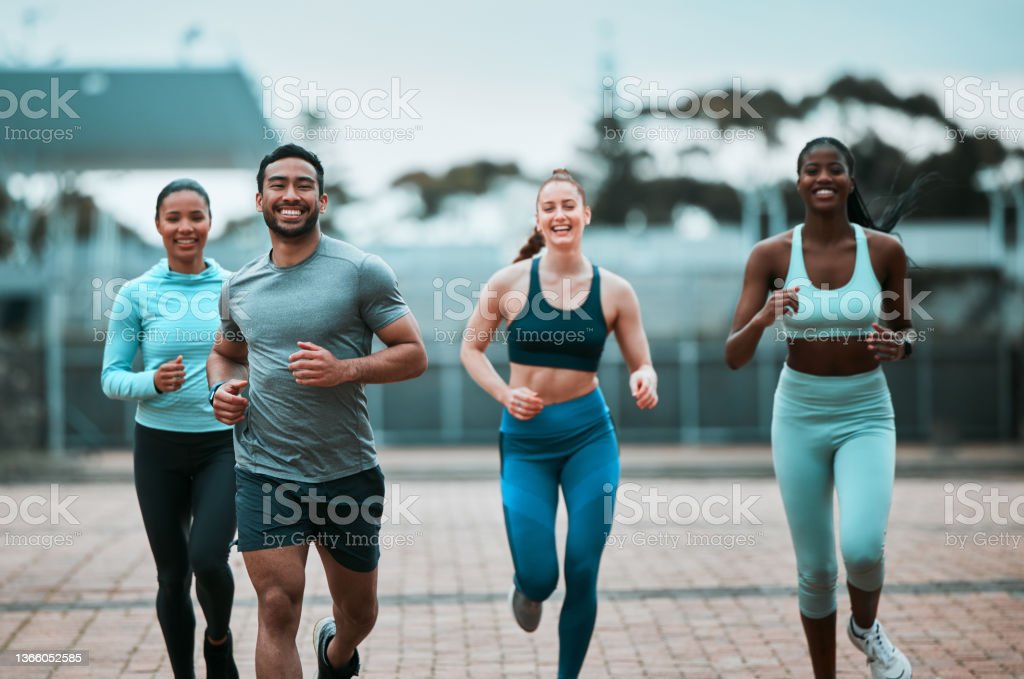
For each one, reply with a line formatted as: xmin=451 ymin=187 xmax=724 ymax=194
xmin=725 ymin=137 xmax=919 ymax=679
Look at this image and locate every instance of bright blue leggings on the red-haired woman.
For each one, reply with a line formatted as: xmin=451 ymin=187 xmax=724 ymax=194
xmin=500 ymin=389 xmax=618 ymax=679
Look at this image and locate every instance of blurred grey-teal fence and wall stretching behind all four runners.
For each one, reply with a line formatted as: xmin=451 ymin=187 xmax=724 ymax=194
xmin=0 ymin=215 xmax=1024 ymax=450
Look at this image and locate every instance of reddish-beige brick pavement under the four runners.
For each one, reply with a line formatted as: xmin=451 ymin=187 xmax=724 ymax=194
xmin=0 ymin=450 xmax=1024 ymax=679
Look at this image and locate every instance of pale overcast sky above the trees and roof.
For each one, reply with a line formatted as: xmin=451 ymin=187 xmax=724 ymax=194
xmin=0 ymin=0 xmax=1024 ymax=242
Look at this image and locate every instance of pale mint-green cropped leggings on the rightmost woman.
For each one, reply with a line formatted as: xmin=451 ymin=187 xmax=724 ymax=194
xmin=771 ymin=367 xmax=896 ymax=619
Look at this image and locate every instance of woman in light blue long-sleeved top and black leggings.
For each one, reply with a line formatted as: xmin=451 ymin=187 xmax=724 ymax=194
xmin=101 ymin=179 xmax=239 ymax=679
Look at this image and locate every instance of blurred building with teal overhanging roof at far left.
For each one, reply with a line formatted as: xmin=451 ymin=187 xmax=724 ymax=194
xmin=0 ymin=68 xmax=267 ymax=451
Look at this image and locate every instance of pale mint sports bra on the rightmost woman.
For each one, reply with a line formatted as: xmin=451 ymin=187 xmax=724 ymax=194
xmin=782 ymin=224 xmax=882 ymax=340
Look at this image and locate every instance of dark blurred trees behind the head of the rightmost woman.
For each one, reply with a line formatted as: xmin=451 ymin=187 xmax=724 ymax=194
xmin=589 ymin=76 xmax=1024 ymax=223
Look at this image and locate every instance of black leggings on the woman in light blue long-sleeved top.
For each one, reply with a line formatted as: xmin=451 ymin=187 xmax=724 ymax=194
xmin=135 ymin=423 xmax=234 ymax=679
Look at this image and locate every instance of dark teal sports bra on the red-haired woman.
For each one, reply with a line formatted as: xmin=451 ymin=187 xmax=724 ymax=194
xmin=507 ymin=257 xmax=608 ymax=373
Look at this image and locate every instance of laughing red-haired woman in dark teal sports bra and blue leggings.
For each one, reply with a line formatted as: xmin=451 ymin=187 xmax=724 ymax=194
xmin=462 ymin=169 xmax=657 ymax=679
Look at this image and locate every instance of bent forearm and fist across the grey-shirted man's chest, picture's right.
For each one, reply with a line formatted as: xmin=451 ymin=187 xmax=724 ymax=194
xmin=288 ymin=312 xmax=427 ymax=387
